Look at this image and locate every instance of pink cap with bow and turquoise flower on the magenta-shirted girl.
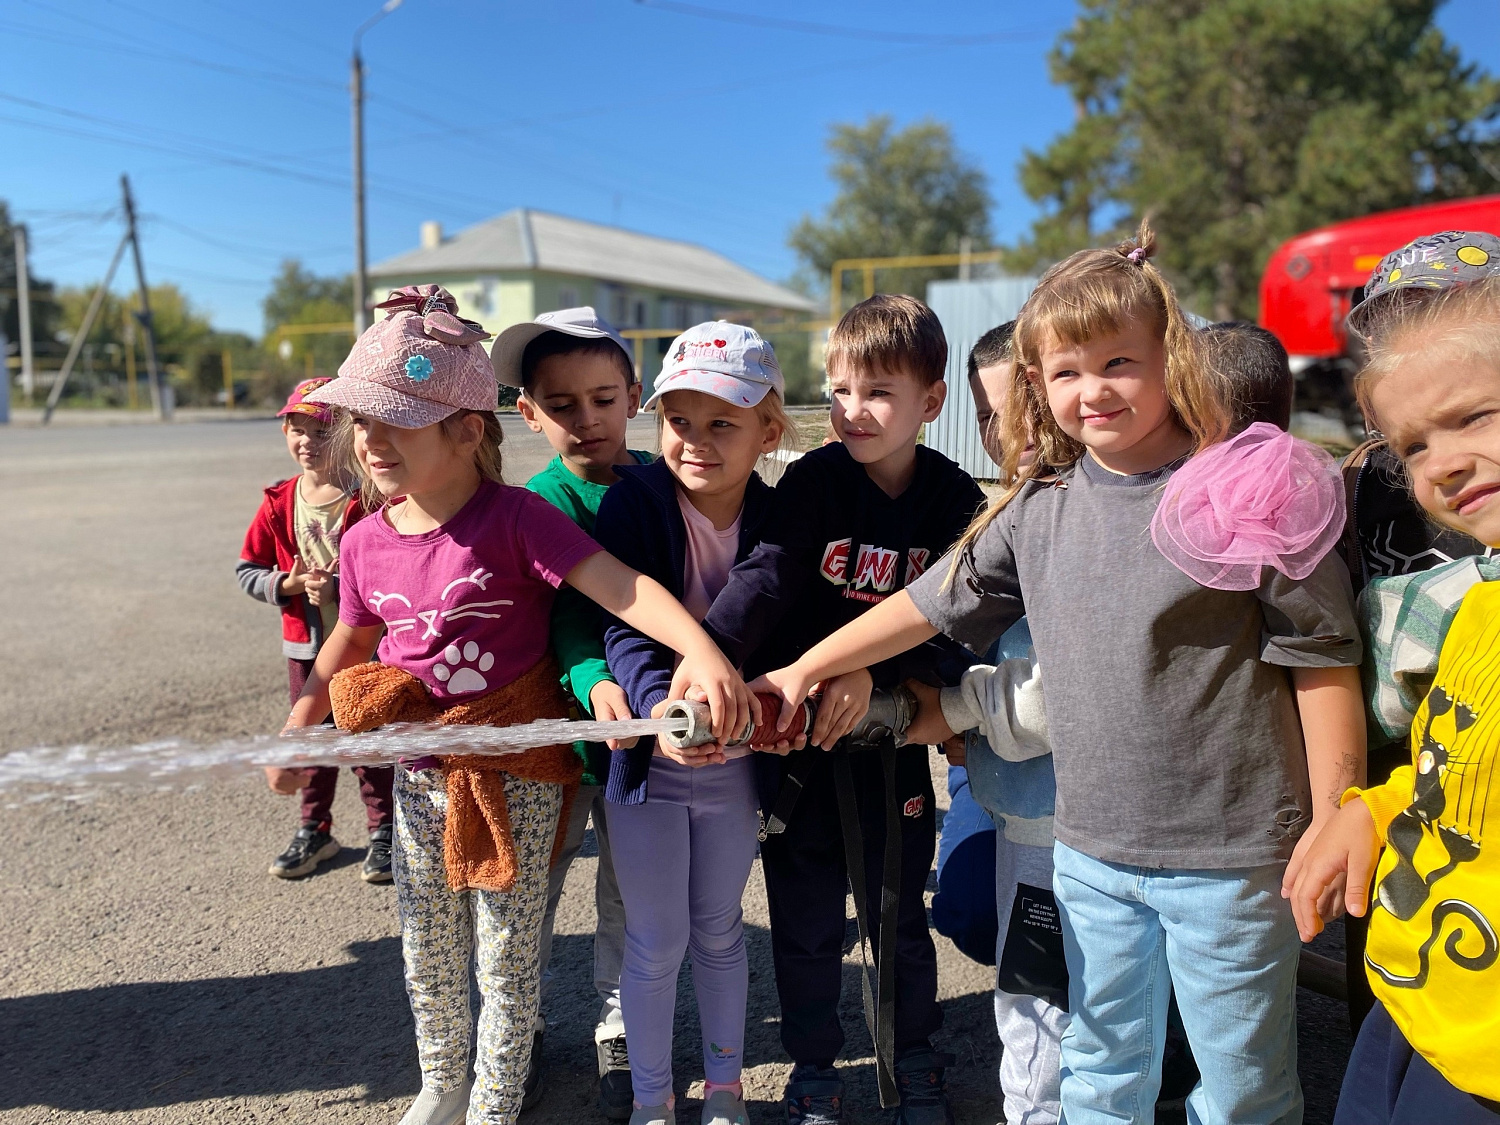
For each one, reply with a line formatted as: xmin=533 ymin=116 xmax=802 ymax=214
xmin=306 ymin=285 xmax=500 ymax=429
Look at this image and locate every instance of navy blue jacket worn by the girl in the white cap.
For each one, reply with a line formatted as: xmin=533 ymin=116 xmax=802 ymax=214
xmin=594 ymin=461 xmax=774 ymax=804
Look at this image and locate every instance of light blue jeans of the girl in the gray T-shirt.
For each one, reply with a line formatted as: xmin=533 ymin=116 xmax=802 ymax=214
xmin=1053 ymin=842 xmax=1302 ymax=1125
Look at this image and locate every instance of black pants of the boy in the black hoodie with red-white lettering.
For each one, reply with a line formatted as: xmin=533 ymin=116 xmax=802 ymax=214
xmin=761 ymin=746 xmax=942 ymax=1065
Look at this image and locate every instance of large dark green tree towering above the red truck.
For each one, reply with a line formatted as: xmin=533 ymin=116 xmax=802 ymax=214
xmin=1008 ymin=0 xmax=1500 ymax=320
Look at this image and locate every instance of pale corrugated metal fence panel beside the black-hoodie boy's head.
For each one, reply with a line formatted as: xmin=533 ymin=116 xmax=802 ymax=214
xmin=926 ymin=278 xmax=1037 ymax=480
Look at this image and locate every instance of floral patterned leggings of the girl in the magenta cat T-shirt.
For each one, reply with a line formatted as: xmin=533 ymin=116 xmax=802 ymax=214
xmin=392 ymin=767 xmax=563 ymax=1125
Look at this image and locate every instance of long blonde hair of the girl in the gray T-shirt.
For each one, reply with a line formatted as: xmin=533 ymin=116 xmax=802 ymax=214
xmin=947 ymin=219 xmax=1232 ymax=584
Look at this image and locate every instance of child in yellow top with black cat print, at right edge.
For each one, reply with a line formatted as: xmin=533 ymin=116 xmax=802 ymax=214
xmin=1287 ymin=279 xmax=1500 ymax=1125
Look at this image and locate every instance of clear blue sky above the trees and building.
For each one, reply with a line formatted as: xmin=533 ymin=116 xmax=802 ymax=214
xmin=0 ymin=0 xmax=1500 ymax=333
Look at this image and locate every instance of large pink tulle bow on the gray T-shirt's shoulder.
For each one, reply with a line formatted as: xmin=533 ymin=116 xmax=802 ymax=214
xmin=1151 ymin=422 xmax=1344 ymax=590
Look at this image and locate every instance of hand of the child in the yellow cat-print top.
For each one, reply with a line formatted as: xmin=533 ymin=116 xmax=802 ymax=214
xmin=1281 ymin=798 xmax=1380 ymax=942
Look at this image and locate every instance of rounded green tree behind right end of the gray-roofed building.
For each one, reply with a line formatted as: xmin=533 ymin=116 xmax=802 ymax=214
xmin=788 ymin=116 xmax=992 ymax=315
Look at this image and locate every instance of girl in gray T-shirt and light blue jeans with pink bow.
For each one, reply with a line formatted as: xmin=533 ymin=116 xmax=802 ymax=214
xmin=758 ymin=224 xmax=1364 ymax=1125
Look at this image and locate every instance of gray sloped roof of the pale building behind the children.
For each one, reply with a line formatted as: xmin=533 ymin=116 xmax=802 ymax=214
xmin=369 ymin=207 xmax=813 ymax=312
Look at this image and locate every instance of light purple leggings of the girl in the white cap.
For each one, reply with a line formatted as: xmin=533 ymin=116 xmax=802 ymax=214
xmin=609 ymin=756 xmax=758 ymax=1106
